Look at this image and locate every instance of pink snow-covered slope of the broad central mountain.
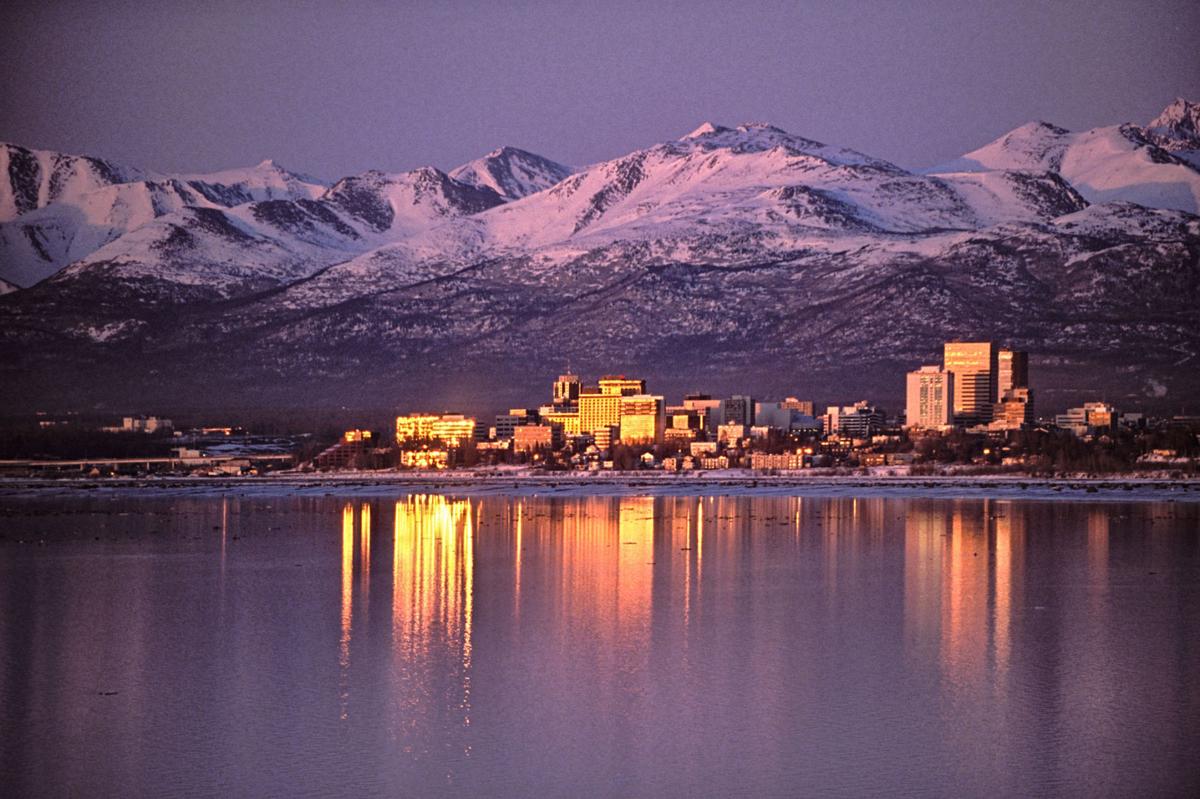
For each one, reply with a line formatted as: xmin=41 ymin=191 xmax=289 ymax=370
xmin=265 ymin=125 xmax=1086 ymax=307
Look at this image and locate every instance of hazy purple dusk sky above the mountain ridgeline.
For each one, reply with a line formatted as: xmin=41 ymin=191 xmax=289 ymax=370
xmin=0 ymin=0 xmax=1200 ymax=178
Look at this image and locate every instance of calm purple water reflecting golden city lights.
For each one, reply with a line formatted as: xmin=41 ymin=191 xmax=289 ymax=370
xmin=0 ymin=497 xmax=1200 ymax=797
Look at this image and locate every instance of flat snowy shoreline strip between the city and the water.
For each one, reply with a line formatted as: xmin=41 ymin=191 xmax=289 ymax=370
xmin=0 ymin=469 xmax=1200 ymax=501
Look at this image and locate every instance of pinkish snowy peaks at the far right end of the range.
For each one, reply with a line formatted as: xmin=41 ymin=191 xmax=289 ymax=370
xmin=929 ymin=101 xmax=1200 ymax=214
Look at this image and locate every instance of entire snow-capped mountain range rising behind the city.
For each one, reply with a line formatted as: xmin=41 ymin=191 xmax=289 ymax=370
xmin=0 ymin=100 xmax=1200 ymax=404
